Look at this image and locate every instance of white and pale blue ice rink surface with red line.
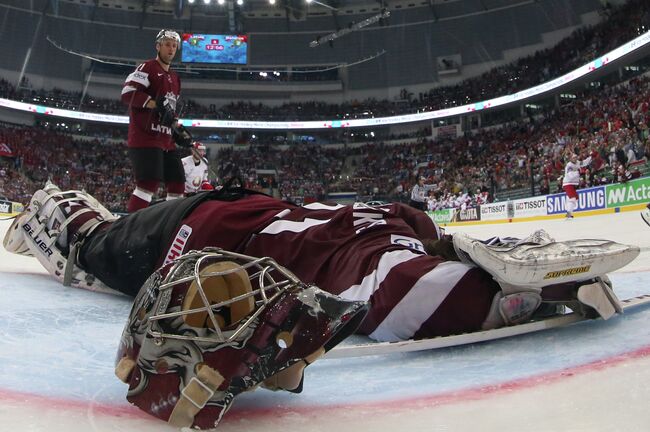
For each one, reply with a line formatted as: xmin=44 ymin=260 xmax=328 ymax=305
xmin=0 ymin=211 xmax=650 ymax=432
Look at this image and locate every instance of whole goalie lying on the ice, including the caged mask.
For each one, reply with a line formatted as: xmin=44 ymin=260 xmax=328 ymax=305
xmin=4 ymin=184 xmax=639 ymax=428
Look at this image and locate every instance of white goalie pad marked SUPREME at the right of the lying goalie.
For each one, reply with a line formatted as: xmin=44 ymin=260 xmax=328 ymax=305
xmin=453 ymin=233 xmax=640 ymax=288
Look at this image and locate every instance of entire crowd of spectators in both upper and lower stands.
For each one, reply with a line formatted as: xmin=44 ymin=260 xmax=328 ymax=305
xmin=0 ymin=1 xmax=650 ymax=210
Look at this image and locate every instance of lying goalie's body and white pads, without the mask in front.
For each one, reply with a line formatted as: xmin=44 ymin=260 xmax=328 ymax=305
xmin=4 ymin=184 xmax=639 ymax=341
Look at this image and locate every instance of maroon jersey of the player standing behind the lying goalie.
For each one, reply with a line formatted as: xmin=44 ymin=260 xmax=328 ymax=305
xmin=122 ymin=59 xmax=181 ymax=150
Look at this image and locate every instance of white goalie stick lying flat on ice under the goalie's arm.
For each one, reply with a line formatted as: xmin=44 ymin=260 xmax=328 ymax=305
xmin=323 ymin=294 xmax=650 ymax=359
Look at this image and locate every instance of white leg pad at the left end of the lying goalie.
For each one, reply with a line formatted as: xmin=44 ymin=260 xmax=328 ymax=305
xmin=3 ymin=182 xmax=118 ymax=293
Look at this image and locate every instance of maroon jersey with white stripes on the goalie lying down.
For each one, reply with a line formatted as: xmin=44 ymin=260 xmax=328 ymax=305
xmin=165 ymin=195 xmax=498 ymax=341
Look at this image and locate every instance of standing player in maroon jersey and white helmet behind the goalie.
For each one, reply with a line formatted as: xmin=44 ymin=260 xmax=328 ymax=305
xmin=122 ymin=30 xmax=191 ymax=213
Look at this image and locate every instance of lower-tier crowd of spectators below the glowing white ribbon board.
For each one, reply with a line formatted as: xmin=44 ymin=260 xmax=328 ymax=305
xmin=0 ymin=72 xmax=650 ymax=211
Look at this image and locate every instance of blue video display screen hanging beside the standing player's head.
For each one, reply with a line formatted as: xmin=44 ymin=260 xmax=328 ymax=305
xmin=181 ymin=33 xmax=248 ymax=64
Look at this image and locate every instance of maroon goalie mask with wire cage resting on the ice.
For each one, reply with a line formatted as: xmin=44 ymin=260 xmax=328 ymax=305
xmin=115 ymin=248 xmax=368 ymax=429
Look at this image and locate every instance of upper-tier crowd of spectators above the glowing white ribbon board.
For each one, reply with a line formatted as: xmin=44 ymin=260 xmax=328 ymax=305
xmin=0 ymin=0 xmax=650 ymax=121
